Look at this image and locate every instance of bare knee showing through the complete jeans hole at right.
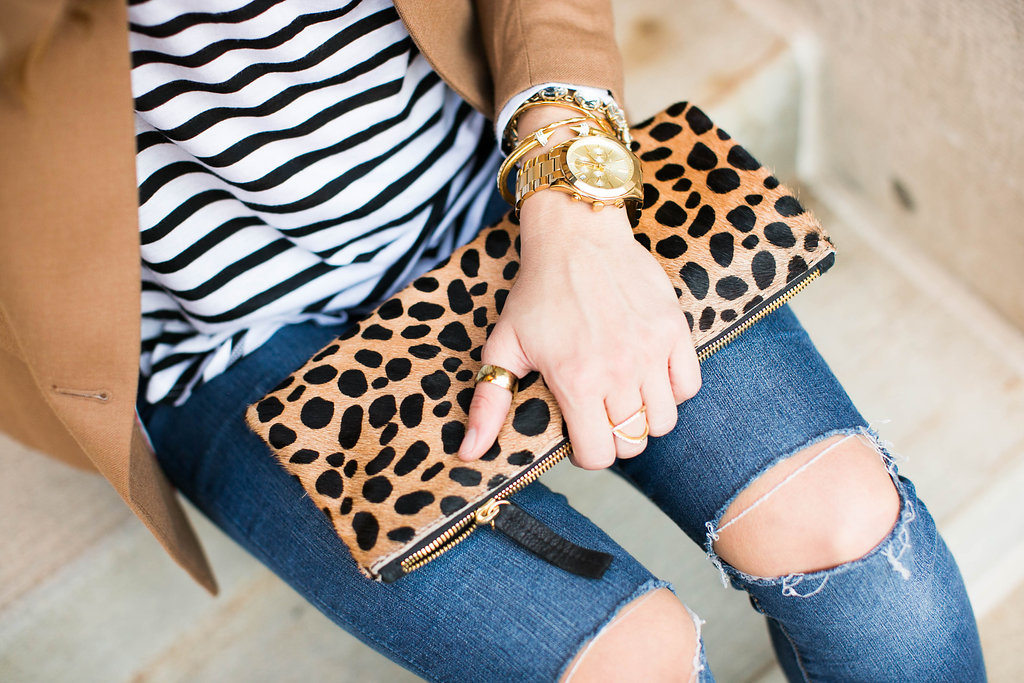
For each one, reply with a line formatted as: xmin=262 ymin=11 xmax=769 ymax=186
xmin=714 ymin=433 xmax=900 ymax=578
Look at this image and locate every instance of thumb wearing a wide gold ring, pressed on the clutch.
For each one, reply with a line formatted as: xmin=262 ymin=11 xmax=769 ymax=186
xmin=459 ymin=321 xmax=532 ymax=461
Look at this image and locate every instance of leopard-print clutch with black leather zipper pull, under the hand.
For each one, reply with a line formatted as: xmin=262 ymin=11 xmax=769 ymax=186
xmin=246 ymin=102 xmax=835 ymax=583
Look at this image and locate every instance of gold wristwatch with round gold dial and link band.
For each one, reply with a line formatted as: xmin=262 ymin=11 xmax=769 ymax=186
xmin=515 ymin=133 xmax=643 ymax=227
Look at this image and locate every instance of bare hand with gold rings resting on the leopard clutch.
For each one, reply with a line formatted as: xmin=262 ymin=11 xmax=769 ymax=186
xmin=459 ymin=190 xmax=700 ymax=469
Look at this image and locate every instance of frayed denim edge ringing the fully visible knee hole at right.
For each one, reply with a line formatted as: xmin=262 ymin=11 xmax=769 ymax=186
xmin=705 ymin=426 xmax=916 ymax=597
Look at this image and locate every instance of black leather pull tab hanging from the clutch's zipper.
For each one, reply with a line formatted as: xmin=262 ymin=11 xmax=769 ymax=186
xmin=490 ymin=501 xmax=611 ymax=579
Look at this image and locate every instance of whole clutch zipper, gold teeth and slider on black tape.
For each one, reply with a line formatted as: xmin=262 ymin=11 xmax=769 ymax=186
xmin=380 ymin=252 xmax=835 ymax=583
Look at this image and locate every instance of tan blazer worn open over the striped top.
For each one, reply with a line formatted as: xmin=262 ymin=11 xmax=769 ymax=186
xmin=0 ymin=0 xmax=622 ymax=595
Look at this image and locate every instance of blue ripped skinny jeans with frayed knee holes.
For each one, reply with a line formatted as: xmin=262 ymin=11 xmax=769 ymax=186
xmin=138 ymin=306 xmax=985 ymax=683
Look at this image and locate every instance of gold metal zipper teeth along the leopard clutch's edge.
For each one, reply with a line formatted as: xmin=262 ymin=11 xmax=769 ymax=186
xmin=393 ymin=262 xmax=821 ymax=573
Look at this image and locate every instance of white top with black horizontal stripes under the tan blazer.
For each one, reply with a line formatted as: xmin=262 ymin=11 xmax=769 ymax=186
xmin=129 ymin=0 xmax=500 ymax=404
